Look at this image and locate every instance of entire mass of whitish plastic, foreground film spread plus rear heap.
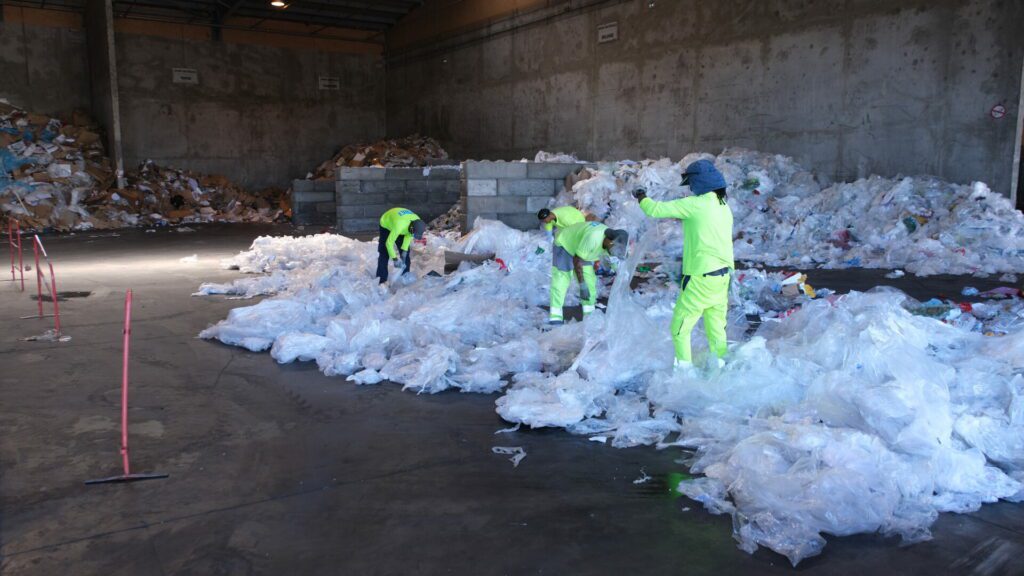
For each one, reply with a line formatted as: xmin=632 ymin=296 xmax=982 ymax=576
xmin=198 ymin=151 xmax=1024 ymax=565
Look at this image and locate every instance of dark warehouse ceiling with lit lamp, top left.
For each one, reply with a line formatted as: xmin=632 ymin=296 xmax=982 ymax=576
xmin=4 ymin=0 xmax=423 ymax=35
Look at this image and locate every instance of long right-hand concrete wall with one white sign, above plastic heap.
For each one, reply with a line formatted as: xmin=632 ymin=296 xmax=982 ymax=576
xmin=387 ymin=0 xmax=1024 ymax=194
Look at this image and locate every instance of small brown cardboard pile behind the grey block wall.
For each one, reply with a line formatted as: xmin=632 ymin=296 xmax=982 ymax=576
xmin=307 ymin=134 xmax=449 ymax=180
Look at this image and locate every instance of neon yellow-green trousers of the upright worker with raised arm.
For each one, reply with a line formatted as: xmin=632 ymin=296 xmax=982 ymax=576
xmin=672 ymin=274 xmax=729 ymax=362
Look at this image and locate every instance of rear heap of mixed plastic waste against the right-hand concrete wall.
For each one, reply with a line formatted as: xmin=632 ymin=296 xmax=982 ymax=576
xmin=555 ymin=149 xmax=1024 ymax=276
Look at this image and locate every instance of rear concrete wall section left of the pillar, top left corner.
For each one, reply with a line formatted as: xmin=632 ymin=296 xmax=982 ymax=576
xmin=0 ymin=6 xmax=90 ymax=116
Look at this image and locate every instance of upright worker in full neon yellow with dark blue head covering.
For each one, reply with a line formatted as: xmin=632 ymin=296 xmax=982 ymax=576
xmin=634 ymin=160 xmax=734 ymax=368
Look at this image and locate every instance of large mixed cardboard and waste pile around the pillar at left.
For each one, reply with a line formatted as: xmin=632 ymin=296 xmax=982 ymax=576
xmin=0 ymin=100 xmax=290 ymax=231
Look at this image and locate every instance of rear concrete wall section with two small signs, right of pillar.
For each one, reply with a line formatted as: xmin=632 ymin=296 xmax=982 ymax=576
xmin=117 ymin=33 xmax=384 ymax=189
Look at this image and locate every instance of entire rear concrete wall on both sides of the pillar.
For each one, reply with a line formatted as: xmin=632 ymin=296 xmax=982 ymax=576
xmin=0 ymin=6 xmax=384 ymax=190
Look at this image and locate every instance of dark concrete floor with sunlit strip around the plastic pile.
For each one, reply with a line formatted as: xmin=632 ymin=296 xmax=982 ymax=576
xmin=0 ymin=227 xmax=1024 ymax=576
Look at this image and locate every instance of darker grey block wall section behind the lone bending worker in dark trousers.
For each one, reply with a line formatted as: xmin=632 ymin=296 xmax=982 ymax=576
xmin=335 ymin=167 xmax=461 ymax=234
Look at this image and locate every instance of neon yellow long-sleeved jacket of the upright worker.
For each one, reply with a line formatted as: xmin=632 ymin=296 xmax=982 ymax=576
xmin=638 ymin=192 xmax=735 ymax=277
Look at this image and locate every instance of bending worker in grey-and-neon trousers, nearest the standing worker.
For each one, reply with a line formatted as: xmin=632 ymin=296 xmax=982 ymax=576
xmin=549 ymin=222 xmax=630 ymax=324
